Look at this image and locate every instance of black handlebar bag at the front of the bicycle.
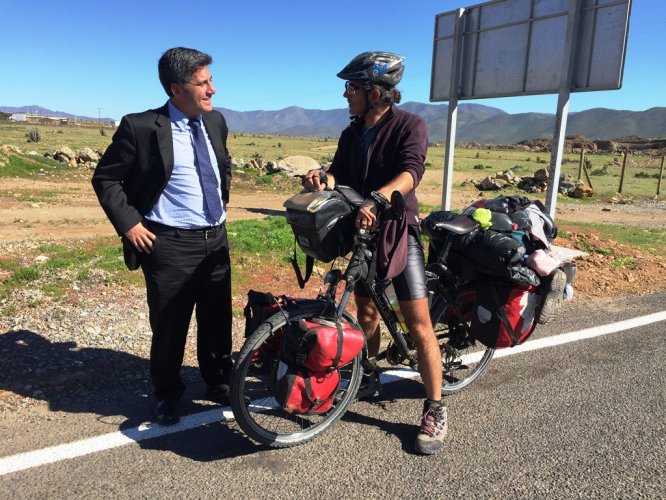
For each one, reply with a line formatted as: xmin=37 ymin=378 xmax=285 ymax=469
xmin=283 ymin=191 xmax=355 ymax=262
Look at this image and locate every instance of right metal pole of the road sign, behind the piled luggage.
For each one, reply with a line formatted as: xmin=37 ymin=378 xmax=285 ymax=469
xmin=546 ymin=0 xmax=582 ymax=220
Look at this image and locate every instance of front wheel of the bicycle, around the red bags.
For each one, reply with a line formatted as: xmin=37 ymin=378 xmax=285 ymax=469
xmin=230 ymin=304 xmax=363 ymax=448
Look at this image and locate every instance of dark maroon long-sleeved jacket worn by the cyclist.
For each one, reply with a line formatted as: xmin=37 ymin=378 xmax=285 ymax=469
xmin=328 ymin=106 xmax=428 ymax=224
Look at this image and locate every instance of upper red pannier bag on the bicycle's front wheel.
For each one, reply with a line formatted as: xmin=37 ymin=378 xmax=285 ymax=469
xmin=281 ymin=318 xmax=365 ymax=372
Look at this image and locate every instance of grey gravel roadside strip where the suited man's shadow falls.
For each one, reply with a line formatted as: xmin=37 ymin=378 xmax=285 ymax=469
xmin=0 ymin=258 xmax=244 ymax=422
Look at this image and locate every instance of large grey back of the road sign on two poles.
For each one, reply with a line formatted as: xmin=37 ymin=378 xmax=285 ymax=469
xmin=430 ymin=0 xmax=631 ymax=101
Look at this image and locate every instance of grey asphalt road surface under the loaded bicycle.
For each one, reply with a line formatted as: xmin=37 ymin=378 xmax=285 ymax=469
xmin=0 ymin=293 xmax=666 ymax=499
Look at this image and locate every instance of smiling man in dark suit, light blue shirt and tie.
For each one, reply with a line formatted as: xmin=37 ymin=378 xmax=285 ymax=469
xmin=92 ymin=47 xmax=232 ymax=425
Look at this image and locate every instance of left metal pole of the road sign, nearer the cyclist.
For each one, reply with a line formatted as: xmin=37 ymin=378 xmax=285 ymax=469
xmin=442 ymin=9 xmax=465 ymax=210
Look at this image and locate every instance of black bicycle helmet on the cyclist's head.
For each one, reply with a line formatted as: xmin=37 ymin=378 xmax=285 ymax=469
xmin=337 ymin=52 xmax=405 ymax=90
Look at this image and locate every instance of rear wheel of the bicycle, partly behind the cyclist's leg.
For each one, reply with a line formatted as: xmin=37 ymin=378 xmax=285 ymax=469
xmin=430 ymin=288 xmax=495 ymax=396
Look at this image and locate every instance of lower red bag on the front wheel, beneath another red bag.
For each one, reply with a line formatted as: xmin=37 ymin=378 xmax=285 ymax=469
xmin=271 ymin=361 xmax=340 ymax=414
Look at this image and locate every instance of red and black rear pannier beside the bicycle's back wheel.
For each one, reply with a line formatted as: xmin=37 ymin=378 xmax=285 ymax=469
xmin=471 ymin=280 xmax=540 ymax=349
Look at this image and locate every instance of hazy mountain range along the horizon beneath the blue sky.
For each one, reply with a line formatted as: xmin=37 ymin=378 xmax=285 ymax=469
xmin=0 ymin=102 xmax=666 ymax=144
